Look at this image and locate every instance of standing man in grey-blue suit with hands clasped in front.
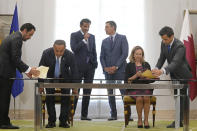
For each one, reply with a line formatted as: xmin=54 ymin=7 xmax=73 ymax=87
xmin=100 ymin=21 xmax=128 ymax=120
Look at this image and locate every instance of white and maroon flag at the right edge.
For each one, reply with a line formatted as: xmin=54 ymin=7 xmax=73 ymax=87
xmin=180 ymin=10 xmax=197 ymax=100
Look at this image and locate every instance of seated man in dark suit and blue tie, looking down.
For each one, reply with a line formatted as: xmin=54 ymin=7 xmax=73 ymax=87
xmin=39 ymin=40 xmax=77 ymax=128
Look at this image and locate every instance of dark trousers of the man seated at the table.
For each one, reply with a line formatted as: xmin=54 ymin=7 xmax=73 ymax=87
xmin=46 ymin=88 xmax=70 ymax=123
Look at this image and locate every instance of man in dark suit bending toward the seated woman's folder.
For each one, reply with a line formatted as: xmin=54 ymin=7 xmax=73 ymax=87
xmin=152 ymin=26 xmax=192 ymax=128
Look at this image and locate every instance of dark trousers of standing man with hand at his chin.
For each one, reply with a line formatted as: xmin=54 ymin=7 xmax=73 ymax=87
xmin=74 ymin=64 xmax=95 ymax=117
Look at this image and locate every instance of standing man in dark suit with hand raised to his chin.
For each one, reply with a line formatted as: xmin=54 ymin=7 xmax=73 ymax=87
xmin=70 ymin=19 xmax=98 ymax=120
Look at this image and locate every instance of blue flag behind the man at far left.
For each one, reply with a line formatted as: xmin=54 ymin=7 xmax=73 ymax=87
xmin=10 ymin=4 xmax=24 ymax=98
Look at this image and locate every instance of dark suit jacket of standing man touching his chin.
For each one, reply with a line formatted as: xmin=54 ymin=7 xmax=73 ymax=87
xmin=70 ymin=31 xmax=98 ymax=70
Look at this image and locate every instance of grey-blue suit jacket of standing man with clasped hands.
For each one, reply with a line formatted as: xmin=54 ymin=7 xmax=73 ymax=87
xmin=100 ymin=33 xmax=129 ymax=73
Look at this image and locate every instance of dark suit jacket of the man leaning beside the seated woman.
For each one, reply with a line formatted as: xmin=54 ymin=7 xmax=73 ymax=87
xmin=156 ymin=38 xmax=192 ymax=79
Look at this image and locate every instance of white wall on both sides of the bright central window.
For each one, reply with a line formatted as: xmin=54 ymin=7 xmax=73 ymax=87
xmin=0 ymin=0 xmax=197 ymax=112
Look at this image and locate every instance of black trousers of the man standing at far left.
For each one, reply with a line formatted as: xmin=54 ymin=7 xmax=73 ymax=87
xmin=0 ymin=78 xmax=13 ymax=125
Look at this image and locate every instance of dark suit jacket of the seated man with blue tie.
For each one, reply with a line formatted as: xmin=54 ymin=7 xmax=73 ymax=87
xmin=39 ymin=47 xmax=78 ymax=82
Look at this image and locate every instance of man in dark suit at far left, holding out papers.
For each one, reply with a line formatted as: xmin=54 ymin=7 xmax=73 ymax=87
xmin=0 ymin=23 xmax=40 ymax=129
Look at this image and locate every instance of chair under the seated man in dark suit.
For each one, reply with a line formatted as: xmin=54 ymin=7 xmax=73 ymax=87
xmin=41 ymin=88 xmax=75 ymax=126
